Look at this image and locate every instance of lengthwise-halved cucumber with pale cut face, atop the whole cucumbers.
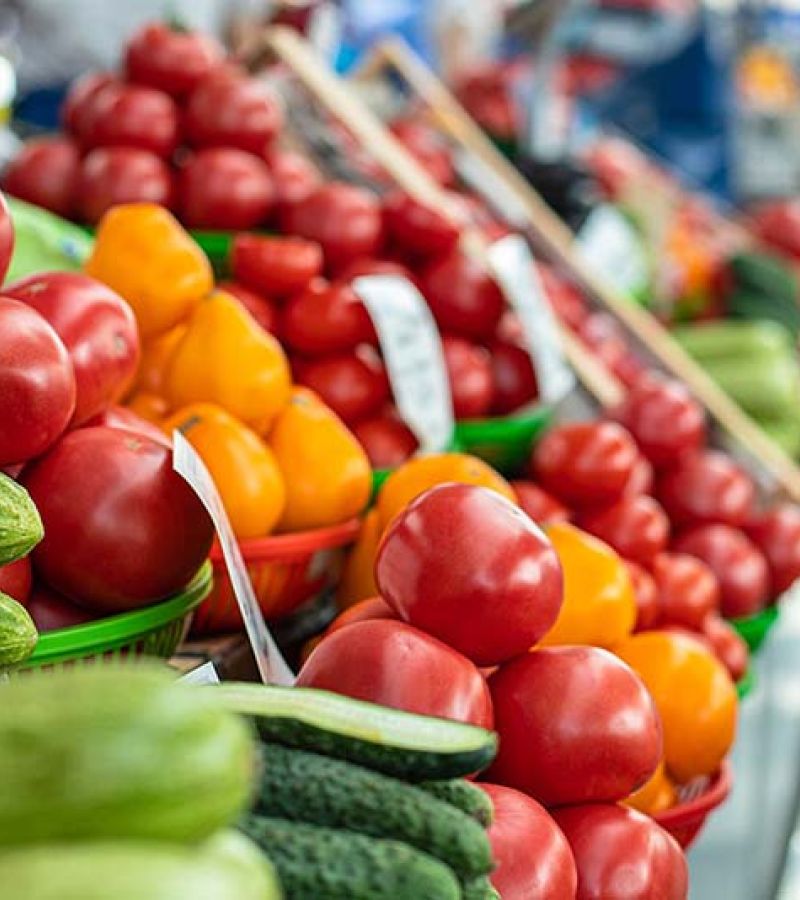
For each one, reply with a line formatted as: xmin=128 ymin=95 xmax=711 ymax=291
xmin=214 ymin=682 xmax=497 ymax=781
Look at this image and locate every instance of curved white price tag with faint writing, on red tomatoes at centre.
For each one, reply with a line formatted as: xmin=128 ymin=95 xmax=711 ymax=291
xmin=353 ymin=275 xmax=455 ymax=453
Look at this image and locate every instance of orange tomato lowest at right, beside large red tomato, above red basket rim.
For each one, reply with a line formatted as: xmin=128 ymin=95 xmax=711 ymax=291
xmin=615 ymin=631 xmax=738 ymax=784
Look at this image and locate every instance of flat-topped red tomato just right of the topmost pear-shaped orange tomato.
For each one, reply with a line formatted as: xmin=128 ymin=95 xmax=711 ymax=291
xmin=230 ymin=234 xmax=322 ymax=297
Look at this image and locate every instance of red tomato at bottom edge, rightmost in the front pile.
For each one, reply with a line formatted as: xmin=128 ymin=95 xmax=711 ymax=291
xmin=553 ymin=804 xmax=689 ymax=900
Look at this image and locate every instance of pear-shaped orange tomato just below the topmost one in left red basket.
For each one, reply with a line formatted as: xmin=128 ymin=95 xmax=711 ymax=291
xmin=166 ymin=291 xmax=291 ymax=433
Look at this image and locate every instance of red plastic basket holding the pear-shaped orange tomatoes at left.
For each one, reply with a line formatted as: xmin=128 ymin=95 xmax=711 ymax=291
xmin=192 ymin=518 xmax=361 ymax=636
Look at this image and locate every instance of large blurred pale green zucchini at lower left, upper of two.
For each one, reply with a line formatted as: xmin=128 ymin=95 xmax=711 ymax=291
xmin=0 ymin=663 xmax=256 ymax=847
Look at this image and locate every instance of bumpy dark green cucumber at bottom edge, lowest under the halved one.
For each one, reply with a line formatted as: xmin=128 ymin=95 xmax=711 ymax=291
xmin=241 ymin=816 xmax=461 ymax=900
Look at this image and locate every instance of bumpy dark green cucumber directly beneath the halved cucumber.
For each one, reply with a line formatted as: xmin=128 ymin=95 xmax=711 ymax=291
xmin=256 ymin=744 xmax=493 ymax=879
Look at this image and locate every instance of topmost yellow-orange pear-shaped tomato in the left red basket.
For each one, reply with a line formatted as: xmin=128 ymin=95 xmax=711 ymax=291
xmin=85 ymin=203 xmax=214 ymax=340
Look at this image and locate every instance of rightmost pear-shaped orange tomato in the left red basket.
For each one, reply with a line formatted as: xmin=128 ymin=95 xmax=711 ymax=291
xmin=268 ymin=387 xmax=372 ymax=531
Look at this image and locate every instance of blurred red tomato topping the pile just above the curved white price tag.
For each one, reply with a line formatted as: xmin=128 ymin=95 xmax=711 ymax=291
xmin=281 ymin=181 xmax=383 ymax=270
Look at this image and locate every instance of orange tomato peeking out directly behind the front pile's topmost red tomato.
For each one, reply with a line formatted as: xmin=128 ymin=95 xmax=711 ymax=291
xmin=377 ymin=453 xmax=517 ymax=529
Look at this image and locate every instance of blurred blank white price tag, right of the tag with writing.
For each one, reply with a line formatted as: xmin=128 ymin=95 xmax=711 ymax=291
xmin=489 ymin=234 xmax=575 ymax=403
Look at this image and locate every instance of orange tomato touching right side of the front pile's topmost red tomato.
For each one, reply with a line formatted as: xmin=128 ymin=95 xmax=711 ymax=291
xmin=539 ymin=522 xmax=636 ymax=648
